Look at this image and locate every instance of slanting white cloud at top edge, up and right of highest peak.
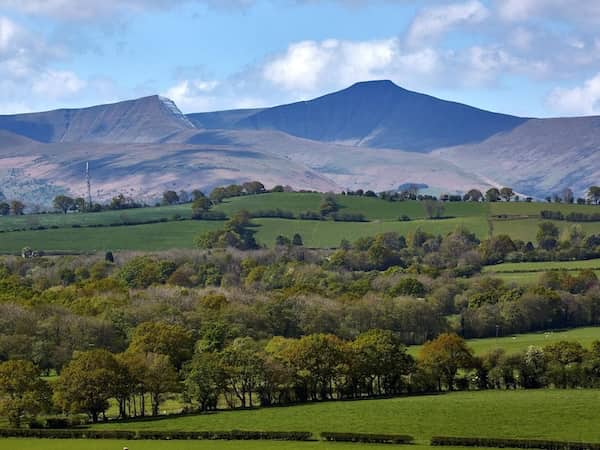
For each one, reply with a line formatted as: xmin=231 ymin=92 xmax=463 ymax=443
xmin=407 ymin=0 xmax=489 ymax=45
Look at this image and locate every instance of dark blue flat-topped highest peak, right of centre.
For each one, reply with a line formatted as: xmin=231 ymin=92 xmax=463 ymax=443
xmin=232 ymin=81 xmax=527 ymax=152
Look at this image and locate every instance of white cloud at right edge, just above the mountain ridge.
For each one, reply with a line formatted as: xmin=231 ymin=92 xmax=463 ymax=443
xmin=547 ymin=73 xmax=600 ymax=115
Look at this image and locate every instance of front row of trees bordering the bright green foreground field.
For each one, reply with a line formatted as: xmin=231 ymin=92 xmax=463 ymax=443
xmin=0 ymin=330 xmax=600 ymax=427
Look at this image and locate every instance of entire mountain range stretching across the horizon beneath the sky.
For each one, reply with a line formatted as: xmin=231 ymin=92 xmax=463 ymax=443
xmin=0 ymin=81 xmax=600 ymax=205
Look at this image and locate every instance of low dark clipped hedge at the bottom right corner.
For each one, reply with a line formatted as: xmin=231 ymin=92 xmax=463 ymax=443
xmin=431 ymin=436 xmax=600 ymax=450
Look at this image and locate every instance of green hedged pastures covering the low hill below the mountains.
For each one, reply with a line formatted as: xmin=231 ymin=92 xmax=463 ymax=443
xmin=0 ymin=193 xmax=600 ymax=253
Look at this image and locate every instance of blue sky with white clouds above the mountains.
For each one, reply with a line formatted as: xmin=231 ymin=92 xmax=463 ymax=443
xmin=0 ymin=0 xmax=600 ymax=117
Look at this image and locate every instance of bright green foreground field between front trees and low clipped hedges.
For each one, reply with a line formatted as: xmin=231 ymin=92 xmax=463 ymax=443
xmin=91 ymin=390 xmax=600 ymax=443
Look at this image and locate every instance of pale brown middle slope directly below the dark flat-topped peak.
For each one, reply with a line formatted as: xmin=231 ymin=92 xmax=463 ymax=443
xmin=175 ymin=130 xmax=490 ymax=192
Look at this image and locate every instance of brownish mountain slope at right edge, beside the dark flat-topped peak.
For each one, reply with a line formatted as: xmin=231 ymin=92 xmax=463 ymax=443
xmin=435 ymin=117 xmax=600 ymax=197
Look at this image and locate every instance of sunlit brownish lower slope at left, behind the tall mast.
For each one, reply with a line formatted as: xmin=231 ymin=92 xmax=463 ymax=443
xmin=0 ymin=139 xmax=341 ymax=206
